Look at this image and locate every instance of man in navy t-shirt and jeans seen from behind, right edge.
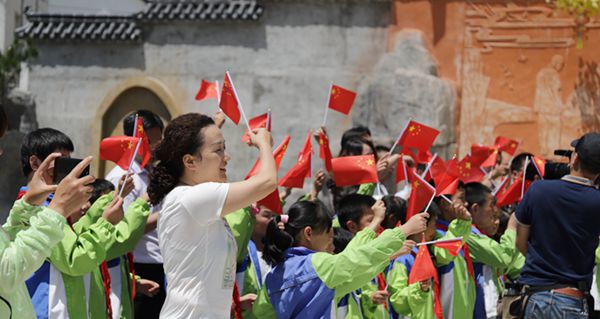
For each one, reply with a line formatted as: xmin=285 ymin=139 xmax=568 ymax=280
xmin=511 ymin=133 xmax=600 ymax=319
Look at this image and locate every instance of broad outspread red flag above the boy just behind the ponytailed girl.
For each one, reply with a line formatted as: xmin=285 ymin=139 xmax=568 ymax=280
xmin=331 ymin=155 xmax=378 ymax=187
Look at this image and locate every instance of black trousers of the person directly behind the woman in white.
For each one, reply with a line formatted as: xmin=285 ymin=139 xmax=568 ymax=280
xmin=133 ymin=263 xmax=167 ymax=319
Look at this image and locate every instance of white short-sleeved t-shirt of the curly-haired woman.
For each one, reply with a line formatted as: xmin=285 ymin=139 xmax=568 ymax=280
xmin=158 ymin=183 xmax=237 ymax=319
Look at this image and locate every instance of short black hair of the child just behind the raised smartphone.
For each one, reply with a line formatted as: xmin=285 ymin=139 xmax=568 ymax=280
xmin=21 ymin=128 xmax=75 ymax=177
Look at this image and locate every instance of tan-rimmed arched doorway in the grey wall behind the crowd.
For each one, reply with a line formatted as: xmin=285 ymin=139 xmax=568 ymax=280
xmin=92 ymin=77 xmax=181 ymax=177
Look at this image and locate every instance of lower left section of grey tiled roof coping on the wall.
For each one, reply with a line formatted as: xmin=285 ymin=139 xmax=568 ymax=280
xmin=15 ymin=14 xmax=142 ymax=41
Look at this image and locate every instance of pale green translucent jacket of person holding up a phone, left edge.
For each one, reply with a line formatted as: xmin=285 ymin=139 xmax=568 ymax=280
xmin=0 ymin=199 xmax=66 ymax=319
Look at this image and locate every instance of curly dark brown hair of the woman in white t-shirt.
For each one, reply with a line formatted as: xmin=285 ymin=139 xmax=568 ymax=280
xmin=148 ymin=113 xmax=215 ymax=204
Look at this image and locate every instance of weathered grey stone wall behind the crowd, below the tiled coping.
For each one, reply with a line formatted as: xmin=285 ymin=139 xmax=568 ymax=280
xmin=0 ymin=1 xmax=454 ymax=219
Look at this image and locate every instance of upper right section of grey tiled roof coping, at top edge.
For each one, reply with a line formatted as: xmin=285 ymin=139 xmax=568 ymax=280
xmin=135 ymin=0 xmax=263 ymax=21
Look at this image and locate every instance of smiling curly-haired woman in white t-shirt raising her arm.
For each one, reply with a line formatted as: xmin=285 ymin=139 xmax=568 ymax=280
xmin=148 ymin=113 xmax=277 ymax=319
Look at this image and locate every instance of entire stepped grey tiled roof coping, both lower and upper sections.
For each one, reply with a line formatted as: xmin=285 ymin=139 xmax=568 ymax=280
xmin=15 ymin=0 xmax=263 ymax=41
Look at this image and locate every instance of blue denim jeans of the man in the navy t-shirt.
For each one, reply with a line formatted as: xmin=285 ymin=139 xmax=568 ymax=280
xmin=524 ymin=291 xmax=588 ymax=319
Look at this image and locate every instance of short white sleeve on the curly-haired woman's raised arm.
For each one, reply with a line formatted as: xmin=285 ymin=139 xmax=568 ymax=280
xmin=181 ymin=183 xmax=229 ymax=224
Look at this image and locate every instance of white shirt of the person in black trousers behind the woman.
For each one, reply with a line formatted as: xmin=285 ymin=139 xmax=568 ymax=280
xmin=106 ymin=162 xmax=162 ymax=264
